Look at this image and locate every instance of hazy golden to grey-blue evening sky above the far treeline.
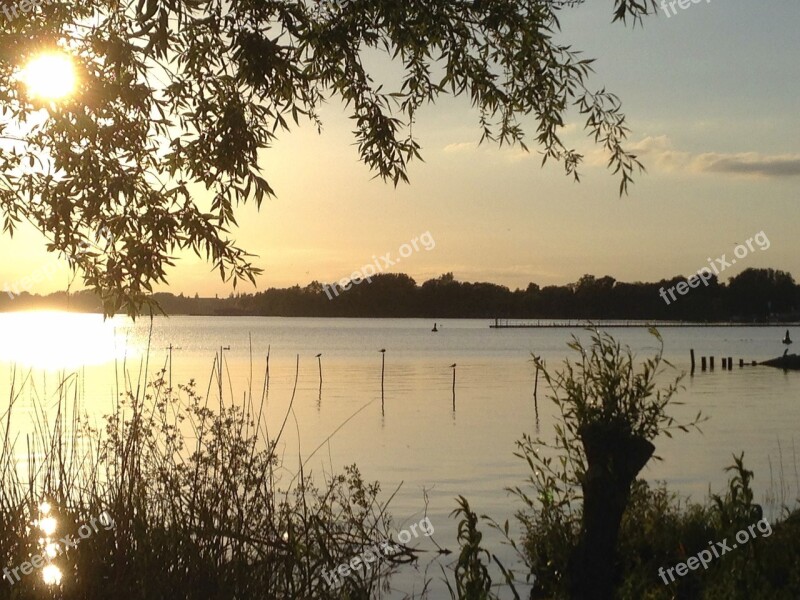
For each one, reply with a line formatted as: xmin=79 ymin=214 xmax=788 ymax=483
xmin=0 ymin=0 xmax=800 ymax=296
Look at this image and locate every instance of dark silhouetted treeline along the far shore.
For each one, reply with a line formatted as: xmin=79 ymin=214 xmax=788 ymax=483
xmin=0 ymin=269 xmax=800 ymax=322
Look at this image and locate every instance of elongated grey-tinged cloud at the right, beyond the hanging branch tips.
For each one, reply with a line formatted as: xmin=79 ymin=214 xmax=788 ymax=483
xmin=630 ymin=135 xmax=800 ymax=177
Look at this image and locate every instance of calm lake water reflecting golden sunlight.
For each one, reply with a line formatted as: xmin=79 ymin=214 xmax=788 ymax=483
xmin=0 ymin=313 xmax=800 ymax=598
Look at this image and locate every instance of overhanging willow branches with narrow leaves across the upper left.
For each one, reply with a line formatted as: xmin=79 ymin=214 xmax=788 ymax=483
xmin=0 ymin=0 xmax=656 ymax=314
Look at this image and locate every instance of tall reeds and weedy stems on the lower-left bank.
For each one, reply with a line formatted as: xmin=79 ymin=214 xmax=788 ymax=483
xmin=0 ymin=350 xmax=410 ymax=600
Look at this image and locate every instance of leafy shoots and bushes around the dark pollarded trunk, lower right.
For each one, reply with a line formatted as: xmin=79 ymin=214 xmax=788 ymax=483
xmin=512 ymin=334 xmax=800 ymax=600
